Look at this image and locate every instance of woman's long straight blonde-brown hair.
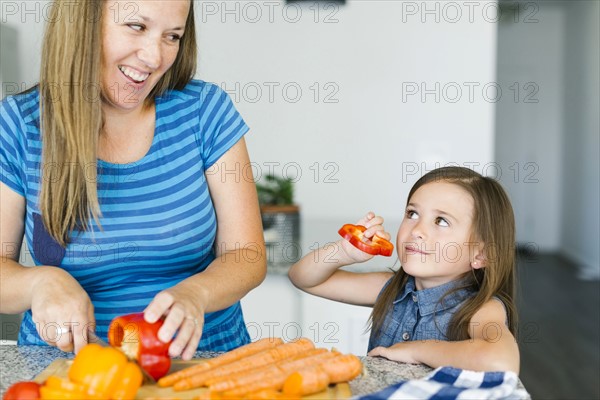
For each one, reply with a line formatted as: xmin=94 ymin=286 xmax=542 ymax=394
xmin=39 ymin=0 xmax=196 ymax=247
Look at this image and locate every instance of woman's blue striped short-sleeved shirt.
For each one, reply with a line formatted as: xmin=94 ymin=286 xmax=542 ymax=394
xmin=0 ymin=80 xmax=250 ymax=350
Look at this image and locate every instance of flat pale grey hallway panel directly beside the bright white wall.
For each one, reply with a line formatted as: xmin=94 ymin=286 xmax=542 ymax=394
xmin=496 ymin=2 xmax=566 ymax=251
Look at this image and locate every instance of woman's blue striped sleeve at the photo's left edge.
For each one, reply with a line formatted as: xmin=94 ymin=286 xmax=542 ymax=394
xmin=0 ymin=98 xmax=26 ymax=196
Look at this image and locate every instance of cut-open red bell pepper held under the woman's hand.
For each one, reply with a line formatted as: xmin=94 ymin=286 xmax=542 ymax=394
xmin=108 ymin=313 xmax=171 ymax=380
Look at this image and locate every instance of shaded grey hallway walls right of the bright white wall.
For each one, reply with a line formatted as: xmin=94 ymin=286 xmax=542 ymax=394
xmin=496 ymin=0 xmax=600 ymax=279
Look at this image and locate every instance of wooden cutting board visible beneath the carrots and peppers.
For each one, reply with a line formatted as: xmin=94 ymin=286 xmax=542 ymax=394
xmin=34 ymin=358 xmax=351 ymax=400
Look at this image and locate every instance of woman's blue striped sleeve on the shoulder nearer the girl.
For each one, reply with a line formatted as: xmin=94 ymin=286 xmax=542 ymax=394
xmin=199 ymin=84 xmax=249 ymax=169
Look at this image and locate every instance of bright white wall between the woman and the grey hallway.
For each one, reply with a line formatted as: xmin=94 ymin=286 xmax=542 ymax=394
xmin=197 ymin=1 xmax=496 ymax=225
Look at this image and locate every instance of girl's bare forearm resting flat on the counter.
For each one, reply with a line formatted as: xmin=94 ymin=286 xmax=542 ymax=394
xmin=402 ymin=339 xmax=519 ymax=374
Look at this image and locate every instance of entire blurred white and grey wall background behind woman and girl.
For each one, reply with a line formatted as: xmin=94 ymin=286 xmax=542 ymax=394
xmin=2 ymin=0 xmax=600 ymax=277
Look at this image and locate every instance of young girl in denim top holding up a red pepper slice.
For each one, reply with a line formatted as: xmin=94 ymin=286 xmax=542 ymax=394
xmin=289 ymin=167 xmax=519 ymax=373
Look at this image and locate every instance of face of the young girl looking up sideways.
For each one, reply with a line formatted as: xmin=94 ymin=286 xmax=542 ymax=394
xmin=396 ymin=181 xmax=482 ymax=290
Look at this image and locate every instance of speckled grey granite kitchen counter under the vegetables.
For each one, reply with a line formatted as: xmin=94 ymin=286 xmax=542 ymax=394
xmin=0 ymin=345 xmax=431 ymax=397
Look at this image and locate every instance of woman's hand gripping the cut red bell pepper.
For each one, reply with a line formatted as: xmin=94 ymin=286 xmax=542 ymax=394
xmin=144 ymin=284 xmax=204 ymax=360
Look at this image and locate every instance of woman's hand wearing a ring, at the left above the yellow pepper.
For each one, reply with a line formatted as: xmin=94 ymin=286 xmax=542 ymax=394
xmin=31 ymin=266 xmax=96 ymax=353
